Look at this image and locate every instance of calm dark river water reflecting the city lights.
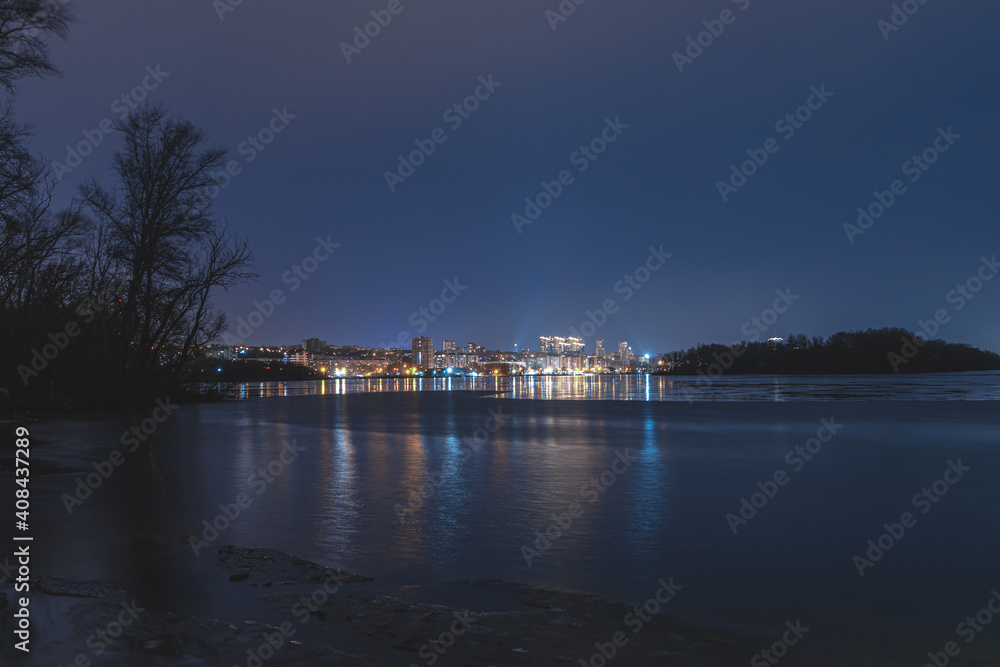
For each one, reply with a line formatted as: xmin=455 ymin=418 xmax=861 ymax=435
xmin=21 ymin=373 xmax=1000 ymax=665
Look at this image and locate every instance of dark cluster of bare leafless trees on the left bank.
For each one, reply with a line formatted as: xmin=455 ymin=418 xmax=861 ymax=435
xmin=0 ymin=0 xmax=254 ymax=407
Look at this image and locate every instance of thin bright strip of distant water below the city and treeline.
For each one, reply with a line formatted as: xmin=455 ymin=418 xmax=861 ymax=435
xmin=203 ymin=372 xmax=1000 ymax=402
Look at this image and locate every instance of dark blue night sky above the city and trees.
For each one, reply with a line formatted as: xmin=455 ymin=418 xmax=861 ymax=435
xmin=19 ymin=0 xmax=1000 ymax=353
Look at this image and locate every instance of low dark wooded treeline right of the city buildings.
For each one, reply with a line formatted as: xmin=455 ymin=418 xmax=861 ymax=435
xmin=661 ymin=328 xmax=1000 ymax=376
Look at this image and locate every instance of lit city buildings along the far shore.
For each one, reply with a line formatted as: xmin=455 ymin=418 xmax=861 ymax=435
xmin=205 ymin=336 xmax=649 ymax=377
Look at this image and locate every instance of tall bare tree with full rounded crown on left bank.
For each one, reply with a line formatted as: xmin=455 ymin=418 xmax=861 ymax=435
xmin=81 ymin=107 xmax=255 ymax=400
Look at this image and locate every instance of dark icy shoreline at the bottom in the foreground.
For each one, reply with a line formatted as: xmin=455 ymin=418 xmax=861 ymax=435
xmin=0 ymin=538 xmax=842 ymax=667
